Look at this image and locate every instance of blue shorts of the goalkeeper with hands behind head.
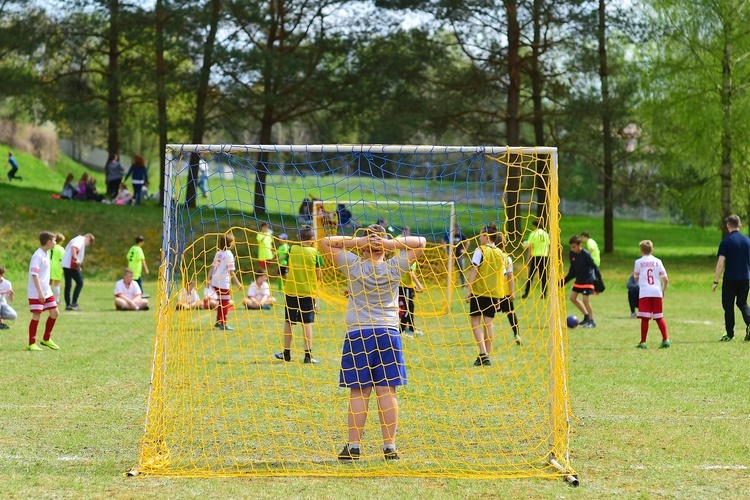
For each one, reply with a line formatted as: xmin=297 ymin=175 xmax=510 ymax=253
xmin=339 ymin=328 xmax=406 ymax=388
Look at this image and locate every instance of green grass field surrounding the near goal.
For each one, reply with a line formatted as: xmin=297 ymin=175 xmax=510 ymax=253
xmin=0 ymin=155 xmax=750 ymax=498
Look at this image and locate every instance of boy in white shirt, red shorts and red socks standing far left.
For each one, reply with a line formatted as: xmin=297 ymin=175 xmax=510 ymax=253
xmin=27 ymin=231 xmax=60 ymax=351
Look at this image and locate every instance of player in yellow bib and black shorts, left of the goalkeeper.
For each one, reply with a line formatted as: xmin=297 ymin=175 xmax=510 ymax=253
xmin=274 ymin=225 xmax=323 ymax=364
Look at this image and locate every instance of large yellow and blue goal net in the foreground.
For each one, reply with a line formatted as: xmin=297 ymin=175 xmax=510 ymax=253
xmin=135 ymin=145 xmax=574 ymax=478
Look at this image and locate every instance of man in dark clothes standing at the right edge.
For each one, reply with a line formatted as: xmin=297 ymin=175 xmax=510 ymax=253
xmin=711 ymin=215 xmax=750 ymax=342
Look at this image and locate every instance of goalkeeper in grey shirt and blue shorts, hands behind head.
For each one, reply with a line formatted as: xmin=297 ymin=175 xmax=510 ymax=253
xmin=320 ymin=224 xmax=426 ymax=461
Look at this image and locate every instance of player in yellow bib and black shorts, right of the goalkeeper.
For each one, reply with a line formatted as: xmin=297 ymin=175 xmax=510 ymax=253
xmin=466 ymin=223 xmax=508 ymax=366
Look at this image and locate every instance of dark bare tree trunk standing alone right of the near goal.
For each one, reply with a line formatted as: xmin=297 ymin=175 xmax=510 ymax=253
xmin=598 ymin=0 xmax=615 ymax=253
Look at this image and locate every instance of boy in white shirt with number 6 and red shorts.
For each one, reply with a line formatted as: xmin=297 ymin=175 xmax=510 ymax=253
xmin=633 ymin=240 xmax=672 ymax=349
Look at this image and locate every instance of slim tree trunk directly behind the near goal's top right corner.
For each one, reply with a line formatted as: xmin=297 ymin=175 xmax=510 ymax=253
xmin=531 ymin=0 xmax=549 ymax=227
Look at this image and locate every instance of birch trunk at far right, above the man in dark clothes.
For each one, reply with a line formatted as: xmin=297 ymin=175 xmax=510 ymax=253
xmin=720 ymin=41 xmax=734 ymax=236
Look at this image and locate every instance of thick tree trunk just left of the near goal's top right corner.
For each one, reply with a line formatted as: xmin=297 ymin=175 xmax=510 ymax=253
xmin=505 ymin=0 xmax=522 ymax=241
